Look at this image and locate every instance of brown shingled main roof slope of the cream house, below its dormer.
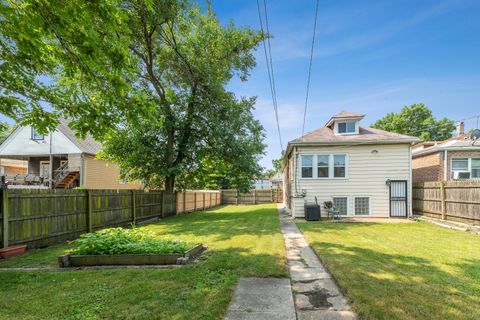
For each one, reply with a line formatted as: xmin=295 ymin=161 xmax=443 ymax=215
xmin=289 ymin=126 xmax=419 ymax=144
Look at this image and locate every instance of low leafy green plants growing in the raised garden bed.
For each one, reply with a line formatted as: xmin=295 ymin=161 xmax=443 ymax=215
xmin=71 ymin=228 xmax=193 ymax=255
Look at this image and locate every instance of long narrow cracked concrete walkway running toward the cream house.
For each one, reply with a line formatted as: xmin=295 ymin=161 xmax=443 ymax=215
xmin=279 ymin=207 xmax=357 ymax=320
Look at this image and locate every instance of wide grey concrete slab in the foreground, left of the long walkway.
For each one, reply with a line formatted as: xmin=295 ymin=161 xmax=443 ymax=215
xmin=226 ymin=278 xmax=296 ymax=320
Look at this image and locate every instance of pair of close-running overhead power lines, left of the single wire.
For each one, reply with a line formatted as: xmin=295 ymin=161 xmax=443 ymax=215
xmin=257 ymin=0 xmax=283 ymax=152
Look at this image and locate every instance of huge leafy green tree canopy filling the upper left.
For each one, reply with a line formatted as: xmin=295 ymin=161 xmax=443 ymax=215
xmin=0 ymin=0 xmax=264 ymax=190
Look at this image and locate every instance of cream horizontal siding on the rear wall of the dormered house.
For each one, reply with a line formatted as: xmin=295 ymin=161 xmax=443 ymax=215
xmin=291 ymin=144 xmax=411 ymax=217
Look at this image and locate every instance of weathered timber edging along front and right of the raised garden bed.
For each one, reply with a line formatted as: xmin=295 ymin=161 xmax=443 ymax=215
xmin=58 ymin=245 xmax=207 ymax=268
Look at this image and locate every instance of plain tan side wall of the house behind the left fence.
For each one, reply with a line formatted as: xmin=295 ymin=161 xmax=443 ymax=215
xmin=84 ymin=156 xmax=141 ymax=189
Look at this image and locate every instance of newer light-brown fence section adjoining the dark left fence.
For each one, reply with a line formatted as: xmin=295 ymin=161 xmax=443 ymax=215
xmin=177 ymin=190 xmax=221 ymax=214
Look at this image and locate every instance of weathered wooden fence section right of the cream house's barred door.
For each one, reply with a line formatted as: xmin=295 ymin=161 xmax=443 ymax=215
xmin=413 ymin=180 xmax=480 ymax=225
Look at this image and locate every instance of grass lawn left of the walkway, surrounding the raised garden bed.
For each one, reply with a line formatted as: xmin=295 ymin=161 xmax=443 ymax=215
xmin=0 ymin=205 xmax=287 ymax=319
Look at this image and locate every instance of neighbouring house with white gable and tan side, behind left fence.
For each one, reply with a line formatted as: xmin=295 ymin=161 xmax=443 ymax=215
xmin=0 ymin=119 xmax=141 ymax=189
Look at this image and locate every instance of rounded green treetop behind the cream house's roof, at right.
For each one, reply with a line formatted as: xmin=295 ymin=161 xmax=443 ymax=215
xmin=372 ymin=103 xmax=455 ymax=141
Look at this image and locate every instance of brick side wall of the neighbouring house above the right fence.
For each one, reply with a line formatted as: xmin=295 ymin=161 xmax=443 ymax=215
xmin=412 ymin=153 xmax=443 ymax=182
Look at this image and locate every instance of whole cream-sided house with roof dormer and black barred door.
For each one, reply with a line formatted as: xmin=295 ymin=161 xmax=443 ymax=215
xmin=282 ymin=112 xmax=418 ymax=217
